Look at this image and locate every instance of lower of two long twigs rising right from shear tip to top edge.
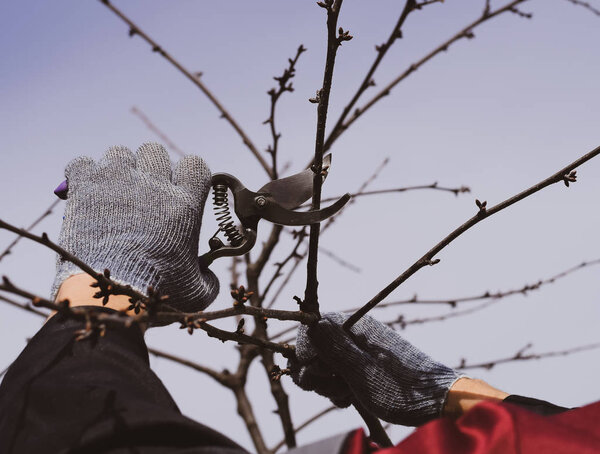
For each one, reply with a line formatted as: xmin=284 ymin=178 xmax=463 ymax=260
xmin=325 ymin=0 xmax=527 ymax=151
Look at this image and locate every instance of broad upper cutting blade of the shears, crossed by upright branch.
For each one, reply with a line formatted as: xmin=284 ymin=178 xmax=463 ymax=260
xmin=258 ymin=153 xmax=331 ymax=210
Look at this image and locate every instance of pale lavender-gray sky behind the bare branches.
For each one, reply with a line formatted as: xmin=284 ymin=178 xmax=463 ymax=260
xmin=0 ymin=0 xmax=600 ymax=449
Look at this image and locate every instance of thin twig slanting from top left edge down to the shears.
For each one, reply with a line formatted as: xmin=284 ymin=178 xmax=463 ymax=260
xmin=100 ymin=0 xmax=272 ymax=177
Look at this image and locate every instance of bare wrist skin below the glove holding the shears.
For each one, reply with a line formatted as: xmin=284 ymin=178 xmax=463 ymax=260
xmin=51 ymin=273 xmax=142 ymax=316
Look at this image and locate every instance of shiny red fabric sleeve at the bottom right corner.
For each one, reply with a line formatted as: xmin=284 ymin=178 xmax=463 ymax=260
xmin=346 ymin=402 xmax=600 ymax=454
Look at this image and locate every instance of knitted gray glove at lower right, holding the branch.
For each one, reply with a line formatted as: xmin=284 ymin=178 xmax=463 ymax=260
xmin=289 ymin=313 xmax=461 ymax=426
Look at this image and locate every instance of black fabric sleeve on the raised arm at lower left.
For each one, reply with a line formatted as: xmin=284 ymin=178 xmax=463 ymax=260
xmin=0 ymin=308 xmax=246 ymax=454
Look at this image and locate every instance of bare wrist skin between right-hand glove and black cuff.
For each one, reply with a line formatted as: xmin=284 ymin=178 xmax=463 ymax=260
xmin=442 ymin=377 xmax=509 ymax=418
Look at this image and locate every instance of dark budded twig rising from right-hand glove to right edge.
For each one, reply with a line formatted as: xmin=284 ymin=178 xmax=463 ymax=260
xmin=344 ymin=146 xmax=600 ymax=330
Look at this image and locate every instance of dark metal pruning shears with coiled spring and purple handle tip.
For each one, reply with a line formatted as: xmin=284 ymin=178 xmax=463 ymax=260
xmin=54 ymin=155 xmax=350 ymax=266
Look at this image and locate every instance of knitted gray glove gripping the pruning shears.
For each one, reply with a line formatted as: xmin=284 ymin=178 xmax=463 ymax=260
xmin=52 ymin=143 xmax=219 ymax=311
